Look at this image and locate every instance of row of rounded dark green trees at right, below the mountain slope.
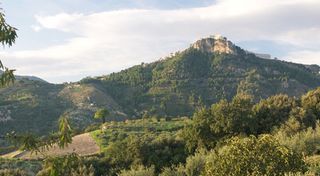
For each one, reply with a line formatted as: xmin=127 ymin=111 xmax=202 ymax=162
xmin=184 ymin=88 xmax=320 ymax=151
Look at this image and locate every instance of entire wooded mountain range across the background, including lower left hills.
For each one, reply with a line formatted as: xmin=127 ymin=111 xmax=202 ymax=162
xmin=0 ymin=36 xmax=320 ymax=134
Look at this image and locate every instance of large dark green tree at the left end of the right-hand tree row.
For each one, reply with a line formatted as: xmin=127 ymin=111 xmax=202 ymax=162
xmin=182 ymin=94 xmax=255 ymax=151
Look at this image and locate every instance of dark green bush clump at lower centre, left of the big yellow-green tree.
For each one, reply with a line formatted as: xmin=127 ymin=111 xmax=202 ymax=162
xmin=105 ymin=135 xmax=187 ymax=173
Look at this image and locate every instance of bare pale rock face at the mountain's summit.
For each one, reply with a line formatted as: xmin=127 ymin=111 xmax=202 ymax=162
xmin=191 ymin=35 xmax=236 ymax=54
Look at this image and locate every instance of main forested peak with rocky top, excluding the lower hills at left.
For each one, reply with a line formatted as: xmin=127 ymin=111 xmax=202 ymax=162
xmin=92 ymin=37 xmax=320 ymax=116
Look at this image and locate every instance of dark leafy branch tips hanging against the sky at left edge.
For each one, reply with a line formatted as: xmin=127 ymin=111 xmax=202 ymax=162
xmin=0 ymin=11 xmax=17 ymax=87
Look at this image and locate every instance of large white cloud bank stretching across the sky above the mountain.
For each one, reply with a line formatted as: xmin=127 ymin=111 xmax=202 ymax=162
xmin=2 ymin=0 xmax=320 ymax=82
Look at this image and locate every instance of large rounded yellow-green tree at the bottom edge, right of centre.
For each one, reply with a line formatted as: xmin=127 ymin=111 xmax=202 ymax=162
xmin=205 ymin=135 xmax=306 ymax=176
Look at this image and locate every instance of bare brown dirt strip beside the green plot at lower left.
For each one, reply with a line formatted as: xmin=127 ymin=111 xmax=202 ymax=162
xmin=2 ymin=133 xmax=100 ymax=159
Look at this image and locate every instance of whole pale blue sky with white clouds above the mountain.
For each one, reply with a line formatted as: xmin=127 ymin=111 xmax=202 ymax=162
xmin=0 ymin=0 xmax=320 ymax=83
